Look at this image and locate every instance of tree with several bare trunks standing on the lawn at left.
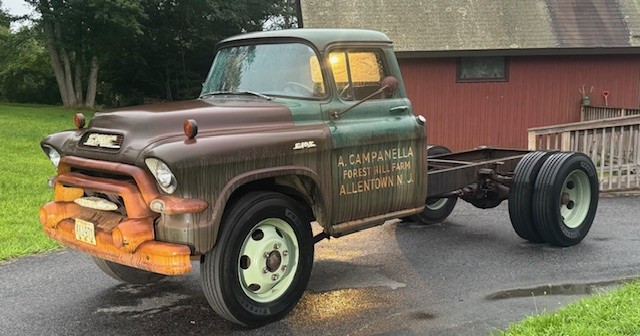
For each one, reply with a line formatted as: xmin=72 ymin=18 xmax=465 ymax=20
xmin=26 ymin=0 xmax=144 ymax=108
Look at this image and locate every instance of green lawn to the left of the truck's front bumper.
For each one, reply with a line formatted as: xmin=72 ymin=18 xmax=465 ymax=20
xmin=0 ymin=104 xmax=94 ymax=261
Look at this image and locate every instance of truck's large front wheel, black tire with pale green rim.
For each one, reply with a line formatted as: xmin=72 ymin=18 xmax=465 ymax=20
xmin=200 ymin=192 xmax=314 ymax=327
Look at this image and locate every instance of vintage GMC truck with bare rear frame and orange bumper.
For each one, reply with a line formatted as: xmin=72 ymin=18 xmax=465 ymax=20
xmin=40 ymin=29 xmax=598 ymax=327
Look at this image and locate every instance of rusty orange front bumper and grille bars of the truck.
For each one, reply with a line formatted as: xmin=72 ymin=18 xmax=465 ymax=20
xmin=40 ymin=157 xmax=207 ymax=275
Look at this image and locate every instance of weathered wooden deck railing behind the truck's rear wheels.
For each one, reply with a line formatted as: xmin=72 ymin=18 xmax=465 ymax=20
xmin=529 ymin=115 xmax=640 ymax=191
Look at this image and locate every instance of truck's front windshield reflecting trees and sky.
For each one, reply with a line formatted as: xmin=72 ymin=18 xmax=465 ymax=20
xmin=201 ymin=43 xmax=325 ymax=98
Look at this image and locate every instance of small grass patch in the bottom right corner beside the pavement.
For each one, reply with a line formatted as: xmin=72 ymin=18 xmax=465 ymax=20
xmin=499 ymin=282 xmax=640 ymax=336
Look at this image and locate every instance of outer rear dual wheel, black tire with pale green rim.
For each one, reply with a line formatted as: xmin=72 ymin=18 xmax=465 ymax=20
xmin=533 ymin=153 xmax=599 ymax=247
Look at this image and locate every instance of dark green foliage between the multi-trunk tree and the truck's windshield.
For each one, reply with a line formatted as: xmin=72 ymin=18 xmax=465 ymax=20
xmin=101 ymin=0 xmax=298 ymax=105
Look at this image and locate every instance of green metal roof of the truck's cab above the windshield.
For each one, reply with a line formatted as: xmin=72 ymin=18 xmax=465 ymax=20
xmin=219 ymin=28 xmax=391 ymax=51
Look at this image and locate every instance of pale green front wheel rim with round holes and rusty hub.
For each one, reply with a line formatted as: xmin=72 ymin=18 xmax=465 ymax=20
xmin=238 ymin=218 xmax=299 ymax=303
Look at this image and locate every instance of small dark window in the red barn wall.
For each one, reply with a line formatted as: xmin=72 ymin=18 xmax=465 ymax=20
xmin=457 ymin=56 xmax=508 ymax=83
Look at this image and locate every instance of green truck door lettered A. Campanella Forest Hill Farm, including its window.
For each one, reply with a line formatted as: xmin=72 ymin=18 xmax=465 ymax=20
xmin=323 ymin=48 xmax=426 ymax=223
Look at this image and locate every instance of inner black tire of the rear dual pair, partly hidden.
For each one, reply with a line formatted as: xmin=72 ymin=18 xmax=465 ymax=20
xmin=509 ymin=152 xmax=553 ymax=243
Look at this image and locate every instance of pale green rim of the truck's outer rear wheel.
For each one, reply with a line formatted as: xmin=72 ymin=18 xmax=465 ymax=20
xmin=560 ymin=170 xmax=591 ymax=229
